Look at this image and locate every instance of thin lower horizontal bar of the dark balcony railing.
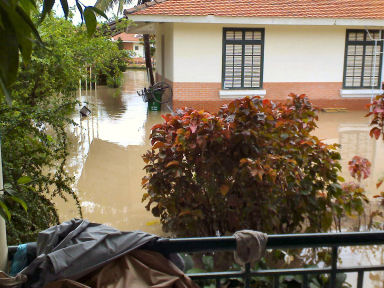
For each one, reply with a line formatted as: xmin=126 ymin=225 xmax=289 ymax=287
xmin=188 ymin=265 xmax=384 ymax=279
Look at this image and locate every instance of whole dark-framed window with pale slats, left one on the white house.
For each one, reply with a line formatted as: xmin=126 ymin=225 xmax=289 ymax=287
xmin=222 ymin=28 xmax=264 ymax=89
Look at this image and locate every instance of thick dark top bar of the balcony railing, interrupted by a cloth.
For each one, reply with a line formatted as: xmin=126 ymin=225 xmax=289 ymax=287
xmin=155 ymin=232 xmax=384 ymax=252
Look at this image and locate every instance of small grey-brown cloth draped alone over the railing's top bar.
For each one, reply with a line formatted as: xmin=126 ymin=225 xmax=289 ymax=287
xmin=233 ymin=230 xmax=268 ymax=265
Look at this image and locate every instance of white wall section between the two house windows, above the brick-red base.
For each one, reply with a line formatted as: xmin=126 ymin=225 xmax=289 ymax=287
xmin=264 ymin=26 xmax=346 ymax=82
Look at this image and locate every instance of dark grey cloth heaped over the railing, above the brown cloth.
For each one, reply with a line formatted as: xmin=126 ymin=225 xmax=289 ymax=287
xmin=19 ymin=219 xmax=158 ymax=288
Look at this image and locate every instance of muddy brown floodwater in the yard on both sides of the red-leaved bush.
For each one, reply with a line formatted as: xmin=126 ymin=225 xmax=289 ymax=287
xmin=57 ymin=71 xmax=384 ymax=234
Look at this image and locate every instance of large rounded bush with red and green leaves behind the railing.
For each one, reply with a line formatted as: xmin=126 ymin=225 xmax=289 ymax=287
xmin=142 ymin=95 xmax=350 ymax=237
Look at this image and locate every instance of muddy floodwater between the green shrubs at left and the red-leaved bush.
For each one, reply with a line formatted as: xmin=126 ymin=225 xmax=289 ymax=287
xmin=57 ymin=71 xmax=168 ymax=234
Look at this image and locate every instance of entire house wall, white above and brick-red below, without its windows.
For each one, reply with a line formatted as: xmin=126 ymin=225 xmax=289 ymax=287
xmin=152 ymin=23 xmax=380 ymax=110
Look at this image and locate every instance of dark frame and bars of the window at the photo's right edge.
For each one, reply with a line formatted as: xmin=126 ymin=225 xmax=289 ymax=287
xmin=342 ymin=29 xmax=384 ymax=90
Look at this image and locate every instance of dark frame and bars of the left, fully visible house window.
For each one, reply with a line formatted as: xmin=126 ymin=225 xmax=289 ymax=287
xmin=221 ymin=27 xmax=265 ymax=90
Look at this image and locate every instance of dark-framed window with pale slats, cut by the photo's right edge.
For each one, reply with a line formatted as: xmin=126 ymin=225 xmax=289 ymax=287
xmin=343 ymin=30 xmax=383 ymax=88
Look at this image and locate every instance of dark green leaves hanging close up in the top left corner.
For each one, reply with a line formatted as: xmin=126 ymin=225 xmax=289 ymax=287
xmin=0 ymin=0 xmax=107 ymax=103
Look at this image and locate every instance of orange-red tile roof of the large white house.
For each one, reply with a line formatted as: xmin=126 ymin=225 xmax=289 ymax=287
xmin=125 ymin=0 xmax=384 ymax=19
